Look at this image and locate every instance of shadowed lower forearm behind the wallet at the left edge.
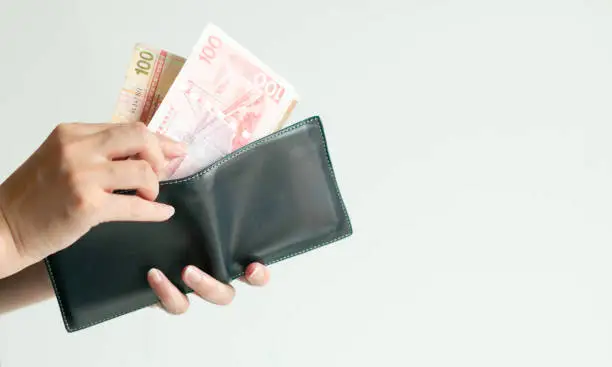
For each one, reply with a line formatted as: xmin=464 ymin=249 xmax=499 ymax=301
xmin=0 ymin=262 xmax=53 ymax=315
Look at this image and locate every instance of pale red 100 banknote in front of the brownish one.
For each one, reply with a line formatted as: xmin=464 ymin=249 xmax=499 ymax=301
xmin=148 ymin=24 xmax=299 ymax=178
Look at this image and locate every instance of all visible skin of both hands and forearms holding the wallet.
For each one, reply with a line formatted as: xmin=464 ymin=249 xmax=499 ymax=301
xmin=0 ymin=123 xmax=270 ymax=314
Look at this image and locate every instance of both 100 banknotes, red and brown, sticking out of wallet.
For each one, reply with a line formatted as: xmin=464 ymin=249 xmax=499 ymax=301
xmin=113 ymin=24 xmax=299 ymax=178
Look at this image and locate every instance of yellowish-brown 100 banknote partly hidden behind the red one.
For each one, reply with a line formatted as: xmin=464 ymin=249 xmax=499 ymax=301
xmin=112 ymin=43 xmax=185 ymax=123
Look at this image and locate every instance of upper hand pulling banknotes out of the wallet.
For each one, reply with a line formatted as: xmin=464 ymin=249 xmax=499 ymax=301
xmin=0 ymin=123 xmax=179 ymax=275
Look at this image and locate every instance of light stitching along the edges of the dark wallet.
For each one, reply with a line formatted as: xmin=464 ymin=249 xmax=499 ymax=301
xmin=45 ymin=116 xmax=352 ymax=331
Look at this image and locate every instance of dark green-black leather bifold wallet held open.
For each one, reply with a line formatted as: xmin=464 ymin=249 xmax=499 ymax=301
xmin=45 ymin=116 xmax=353 ymax=332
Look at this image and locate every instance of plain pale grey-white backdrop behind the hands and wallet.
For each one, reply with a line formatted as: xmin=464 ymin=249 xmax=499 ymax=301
xmin=0 ymin=0 xmax=612 ymax=367
